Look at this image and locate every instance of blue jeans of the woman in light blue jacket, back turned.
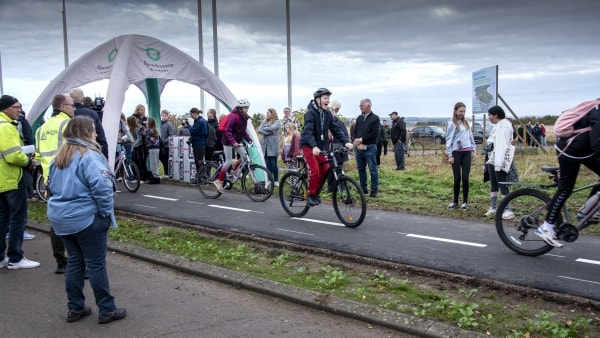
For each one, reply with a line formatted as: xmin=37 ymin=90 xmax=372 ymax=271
xmin=61 ymin=215 xmax=116 ymax=315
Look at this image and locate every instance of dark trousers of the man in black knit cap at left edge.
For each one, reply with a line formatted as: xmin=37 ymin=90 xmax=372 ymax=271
xmin=0 ymin=187 xmax=27 ymax=263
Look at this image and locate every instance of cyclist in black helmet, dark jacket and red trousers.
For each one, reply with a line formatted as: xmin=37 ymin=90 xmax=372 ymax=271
xmin=300 ymin=88 xmax=352 ymax=207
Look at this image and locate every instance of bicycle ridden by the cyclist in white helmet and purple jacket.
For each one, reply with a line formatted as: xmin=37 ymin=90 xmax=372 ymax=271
xmin=196 ymin=145 xmax=275 ymax=202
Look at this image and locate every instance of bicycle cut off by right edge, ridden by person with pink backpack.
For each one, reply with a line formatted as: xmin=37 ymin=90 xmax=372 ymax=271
xmin=496 ymin=166 xmax=600 ymax=256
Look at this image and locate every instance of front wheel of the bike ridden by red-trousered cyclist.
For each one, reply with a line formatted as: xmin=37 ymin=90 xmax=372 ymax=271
xmin=332 ymin=176 xmax=367 ymax=228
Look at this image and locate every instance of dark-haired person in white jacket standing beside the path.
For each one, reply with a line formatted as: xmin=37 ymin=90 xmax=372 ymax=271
xmin=485 ymin=106 xmax=514 ymax=219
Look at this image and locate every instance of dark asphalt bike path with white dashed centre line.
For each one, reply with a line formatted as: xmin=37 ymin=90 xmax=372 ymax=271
xmin=115 ymin=184 xmax=600 ymax=300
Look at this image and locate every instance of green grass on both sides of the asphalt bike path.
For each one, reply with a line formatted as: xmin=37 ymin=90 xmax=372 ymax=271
xmin=29 ymin=154 xmax=600 ymax=337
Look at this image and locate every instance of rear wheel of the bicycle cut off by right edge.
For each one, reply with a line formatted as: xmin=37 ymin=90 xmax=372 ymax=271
xmin=496 ymin=188 xmax=562 ymax=256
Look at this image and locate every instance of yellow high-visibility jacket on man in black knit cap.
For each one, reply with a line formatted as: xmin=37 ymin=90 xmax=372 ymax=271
xmin=0 ymin=112 xmax=31 ymax=193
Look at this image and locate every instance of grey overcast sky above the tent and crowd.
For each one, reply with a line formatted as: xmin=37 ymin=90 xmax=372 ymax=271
xmin=0 ymin=0 xmax=600 ymax=117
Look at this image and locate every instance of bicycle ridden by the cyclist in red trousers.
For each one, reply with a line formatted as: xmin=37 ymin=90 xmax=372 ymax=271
xmin=279 ymin=148 xmax=367 ymax=228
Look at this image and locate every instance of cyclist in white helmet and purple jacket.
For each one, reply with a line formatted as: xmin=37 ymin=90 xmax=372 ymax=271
xmin=214 ymin=99 xmax=252 ymax=193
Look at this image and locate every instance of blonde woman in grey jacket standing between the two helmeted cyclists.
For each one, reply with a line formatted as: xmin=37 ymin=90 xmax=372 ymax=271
xmin=257 ymin=108 xmax=281 ymax=186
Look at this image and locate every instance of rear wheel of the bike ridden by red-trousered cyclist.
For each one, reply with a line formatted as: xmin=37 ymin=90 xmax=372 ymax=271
xmin=279 ymin=171 xmax=310 ymax=217
